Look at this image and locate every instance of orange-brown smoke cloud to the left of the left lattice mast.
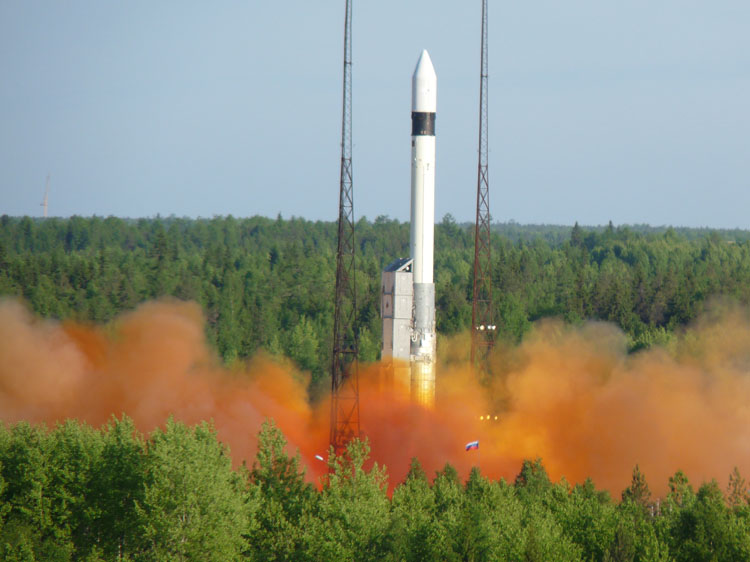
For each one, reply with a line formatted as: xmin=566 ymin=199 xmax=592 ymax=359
xmin=0 ymin=301 xmax=328 ymax=468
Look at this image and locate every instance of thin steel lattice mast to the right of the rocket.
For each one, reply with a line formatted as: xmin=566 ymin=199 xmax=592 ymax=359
xmin=471 ymin=0 xmax=495 ymax=365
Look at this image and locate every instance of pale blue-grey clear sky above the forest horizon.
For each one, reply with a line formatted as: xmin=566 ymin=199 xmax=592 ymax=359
xmin=0 ymin=0 xmax=750 ymax=228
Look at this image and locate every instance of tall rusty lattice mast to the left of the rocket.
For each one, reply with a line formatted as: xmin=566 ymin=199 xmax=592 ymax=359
xmin=331 ymin=0 xmax=360 ymax=455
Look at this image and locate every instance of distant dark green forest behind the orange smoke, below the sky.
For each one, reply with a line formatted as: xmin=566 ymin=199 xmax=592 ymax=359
xmin=0 ymin=215 xmax=750 ymax=384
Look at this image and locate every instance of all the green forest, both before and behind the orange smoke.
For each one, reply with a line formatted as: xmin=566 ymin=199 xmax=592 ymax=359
xmin=0 ymin=215 xmax=750 ymax=561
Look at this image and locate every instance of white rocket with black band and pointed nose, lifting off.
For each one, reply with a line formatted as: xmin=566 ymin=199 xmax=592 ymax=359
xmin=410 ymin=51 xmax=437 ymax=406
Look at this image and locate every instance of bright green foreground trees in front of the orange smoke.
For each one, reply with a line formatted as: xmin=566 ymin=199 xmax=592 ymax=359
xmin=0 ymin=418 xmax=750 ymax=562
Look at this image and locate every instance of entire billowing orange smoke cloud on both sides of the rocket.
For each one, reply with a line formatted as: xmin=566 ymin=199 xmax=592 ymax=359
xmin=0 ymin=301 xmax=750 ymax=497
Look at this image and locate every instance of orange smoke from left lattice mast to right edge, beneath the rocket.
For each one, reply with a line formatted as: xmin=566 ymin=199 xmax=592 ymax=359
xmin=361 ymin=304 xmax=750 ymax=497
